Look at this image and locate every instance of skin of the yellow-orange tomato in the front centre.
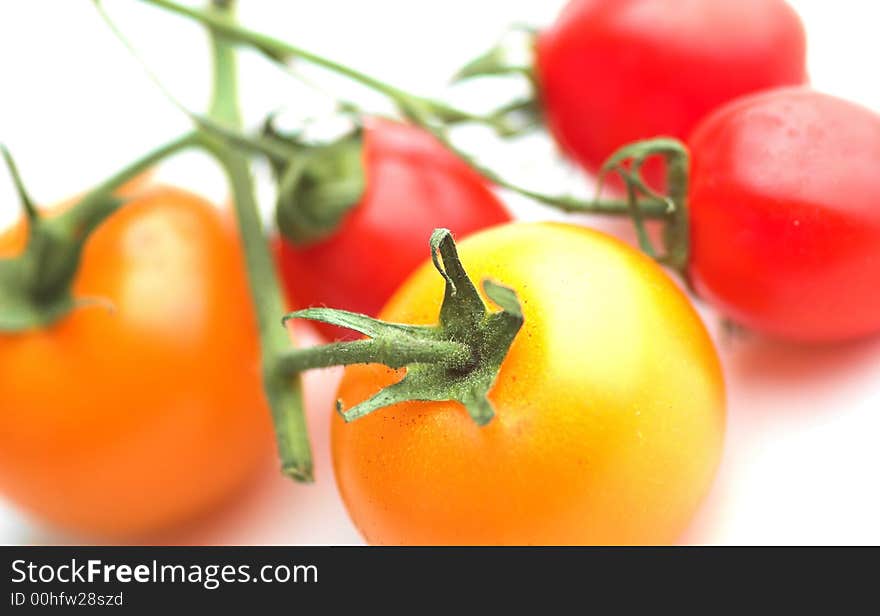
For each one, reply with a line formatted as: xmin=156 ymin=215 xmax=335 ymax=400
xmin=332 ymin=223 xmax=725 ymax=545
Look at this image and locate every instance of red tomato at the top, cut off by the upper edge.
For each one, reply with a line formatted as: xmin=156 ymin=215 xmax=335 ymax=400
xmin=536 ymin=0 xmax=807 ymax=186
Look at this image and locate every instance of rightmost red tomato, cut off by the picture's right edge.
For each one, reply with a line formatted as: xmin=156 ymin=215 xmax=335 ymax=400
xmin=689 ymin=88 xmax=880 ymax=342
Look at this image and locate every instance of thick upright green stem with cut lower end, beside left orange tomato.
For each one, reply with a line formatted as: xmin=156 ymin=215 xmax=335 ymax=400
xmin=202 ymin=0 xmax=313 ymax=481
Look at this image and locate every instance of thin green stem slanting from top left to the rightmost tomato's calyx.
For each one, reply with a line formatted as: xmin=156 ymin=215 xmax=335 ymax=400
xmin=136 ymin=0 xmax=668 ymax=219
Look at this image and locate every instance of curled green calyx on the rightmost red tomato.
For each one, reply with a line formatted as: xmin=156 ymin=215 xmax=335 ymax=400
xmin=596 ymin=137 xmax=690 ymax=282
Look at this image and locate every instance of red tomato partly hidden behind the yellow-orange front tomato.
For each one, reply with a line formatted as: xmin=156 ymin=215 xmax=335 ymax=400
xmin=277 ymin=119 xmax=511 ymax=338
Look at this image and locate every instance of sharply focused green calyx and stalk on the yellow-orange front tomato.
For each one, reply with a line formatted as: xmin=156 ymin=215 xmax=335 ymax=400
xmin=280 ymin=229 xmax=523 ymax=426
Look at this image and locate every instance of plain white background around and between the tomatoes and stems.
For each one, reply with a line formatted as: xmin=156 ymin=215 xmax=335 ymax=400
xmin=0 ymin=0 xmax=880 ymax=544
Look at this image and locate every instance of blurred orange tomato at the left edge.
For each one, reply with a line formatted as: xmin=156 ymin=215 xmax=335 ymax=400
xmin=0 ymin=188 xmax=272 ymax=538
